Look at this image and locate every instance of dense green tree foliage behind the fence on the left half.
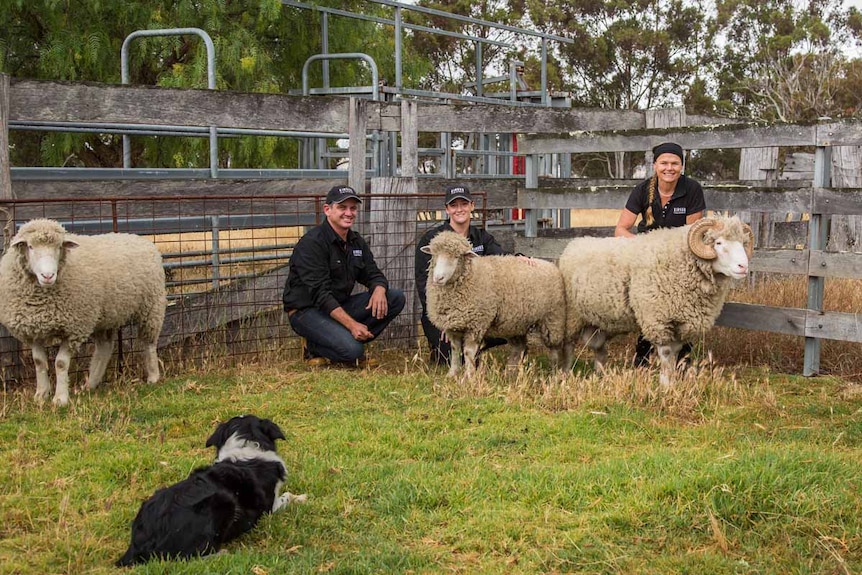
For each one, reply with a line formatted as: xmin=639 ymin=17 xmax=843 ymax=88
xmin=0 ymin=0 xmax=426 ymax=168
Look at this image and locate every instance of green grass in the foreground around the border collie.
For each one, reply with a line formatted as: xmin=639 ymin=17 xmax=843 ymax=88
xmin=0 ymin=360 xmax=862 ymax=575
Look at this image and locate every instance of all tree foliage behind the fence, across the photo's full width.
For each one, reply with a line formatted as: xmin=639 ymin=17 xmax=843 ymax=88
xmin=5 ymin=0 xmax=862 ymax=168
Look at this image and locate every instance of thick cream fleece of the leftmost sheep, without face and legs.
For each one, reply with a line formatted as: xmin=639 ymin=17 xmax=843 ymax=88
xmin=0 ymin=220 xmax=167 ymax=353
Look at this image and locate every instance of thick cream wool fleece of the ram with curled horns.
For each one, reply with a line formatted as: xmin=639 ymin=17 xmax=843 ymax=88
xmin=559 ymin=214 xmax=747 ymax=345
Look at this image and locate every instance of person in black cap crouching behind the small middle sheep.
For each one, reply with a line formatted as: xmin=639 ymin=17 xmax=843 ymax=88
xmin=414 ymin=186 xmax=508 ymax=365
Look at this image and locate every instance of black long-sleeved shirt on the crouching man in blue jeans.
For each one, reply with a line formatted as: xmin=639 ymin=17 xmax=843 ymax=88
xmin=281 ymin=220 xmax=389 ymax=315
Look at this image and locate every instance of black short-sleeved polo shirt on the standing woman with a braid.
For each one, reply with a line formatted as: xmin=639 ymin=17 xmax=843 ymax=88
xmin=626 ymin=175 xmax=706 ymax=233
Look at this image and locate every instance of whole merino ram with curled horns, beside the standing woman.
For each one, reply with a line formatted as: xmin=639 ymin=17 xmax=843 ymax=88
xmin=559 ymin=217 xmax=754 ymax=385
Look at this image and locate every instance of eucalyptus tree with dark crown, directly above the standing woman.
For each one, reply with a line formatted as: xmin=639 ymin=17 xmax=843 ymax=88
xmin=526 ymin=0 xmax=713 ymax=109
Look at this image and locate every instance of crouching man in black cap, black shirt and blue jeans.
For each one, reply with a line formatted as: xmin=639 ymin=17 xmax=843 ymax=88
xmin=282 ymin=186 xmax=404 ymax=365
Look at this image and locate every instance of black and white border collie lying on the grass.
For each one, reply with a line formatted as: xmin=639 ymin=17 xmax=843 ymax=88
xmin=117 ymin=415 xmax=306 ymax=567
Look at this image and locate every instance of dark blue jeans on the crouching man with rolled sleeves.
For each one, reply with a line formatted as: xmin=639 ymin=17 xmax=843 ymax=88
xmin=289 ymin=288 xmax=404 ymax=362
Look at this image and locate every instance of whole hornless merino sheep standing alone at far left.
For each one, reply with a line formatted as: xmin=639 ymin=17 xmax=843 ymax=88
xmin=0 ymin=219 xmax=167 ymax=405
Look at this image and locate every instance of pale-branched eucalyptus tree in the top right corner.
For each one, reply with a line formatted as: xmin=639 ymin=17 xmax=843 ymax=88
xmin=716 ymin=0 xmax=862 ymax=122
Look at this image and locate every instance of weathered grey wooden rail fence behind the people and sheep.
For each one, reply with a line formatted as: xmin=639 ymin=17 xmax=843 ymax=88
xmin=0 ymin=75 xmax=862 ymax=380
